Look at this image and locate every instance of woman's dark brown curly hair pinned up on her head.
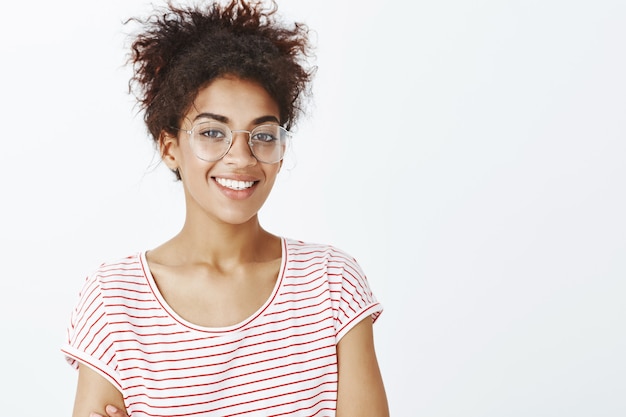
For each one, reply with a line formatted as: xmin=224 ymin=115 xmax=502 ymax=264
xmin=126 ymin=0 xmax=315 ymax=144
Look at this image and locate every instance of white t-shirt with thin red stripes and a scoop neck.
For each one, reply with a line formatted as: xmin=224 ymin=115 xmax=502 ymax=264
xmin=62 ymin=239 xmax=382 ymax=417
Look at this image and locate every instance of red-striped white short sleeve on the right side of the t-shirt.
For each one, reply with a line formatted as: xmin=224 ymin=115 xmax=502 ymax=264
xmin=330 ymin=251 xmax=383 ymax=342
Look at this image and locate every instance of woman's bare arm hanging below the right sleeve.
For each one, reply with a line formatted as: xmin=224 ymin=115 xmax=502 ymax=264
xmin=337 ymin=316 xmax=389 ymax=417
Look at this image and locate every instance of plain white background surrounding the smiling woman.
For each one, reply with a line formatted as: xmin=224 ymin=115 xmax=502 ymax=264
xmin=0 ymin=0 xmax=626 ymax=417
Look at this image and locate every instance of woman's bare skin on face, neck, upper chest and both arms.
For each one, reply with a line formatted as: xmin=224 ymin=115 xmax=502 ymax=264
xmin=73 ymin=77 xmax=389 ymax=417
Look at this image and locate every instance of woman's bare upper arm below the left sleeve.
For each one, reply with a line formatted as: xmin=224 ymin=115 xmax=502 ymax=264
xmin=72 ymin=364 xmax=126 ymax=417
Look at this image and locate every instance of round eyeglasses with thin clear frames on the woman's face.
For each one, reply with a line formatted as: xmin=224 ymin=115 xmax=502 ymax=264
xmin=178 ymin=121 xmax=291 ymax=164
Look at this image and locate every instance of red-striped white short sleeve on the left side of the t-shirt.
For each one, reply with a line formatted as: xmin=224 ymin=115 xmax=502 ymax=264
xmin=61 ymin=274 xmax=121 ymax=389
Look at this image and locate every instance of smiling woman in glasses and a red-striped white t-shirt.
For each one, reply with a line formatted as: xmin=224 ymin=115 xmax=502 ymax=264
xmin=63 ymin=0 xmax=388 ymax=417
